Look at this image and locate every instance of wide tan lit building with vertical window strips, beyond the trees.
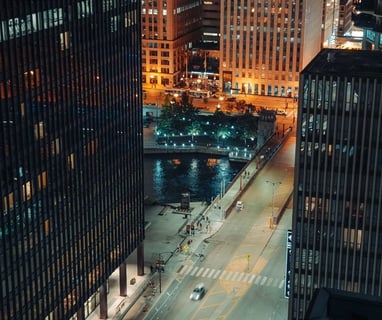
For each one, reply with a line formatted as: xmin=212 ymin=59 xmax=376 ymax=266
xmin=220 ymin=0 xmax=323 ymax=96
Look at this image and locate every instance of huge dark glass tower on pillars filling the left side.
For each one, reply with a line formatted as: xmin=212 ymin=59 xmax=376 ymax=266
xmin=0 ymin=0 xmax=144 ymax=320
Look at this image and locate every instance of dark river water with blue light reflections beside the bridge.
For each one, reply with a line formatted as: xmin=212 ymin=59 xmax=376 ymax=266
xmin=144 ymin=154 xmax=244 ymax=203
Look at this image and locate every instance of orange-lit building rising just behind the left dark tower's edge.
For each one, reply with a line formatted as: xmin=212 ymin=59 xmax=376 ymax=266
xmin=141 ymin=0 xmax=202 ymax=88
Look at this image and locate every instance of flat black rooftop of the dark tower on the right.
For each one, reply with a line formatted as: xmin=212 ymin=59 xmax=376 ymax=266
xmin=302 ymin=49 xmax=382 ymax=78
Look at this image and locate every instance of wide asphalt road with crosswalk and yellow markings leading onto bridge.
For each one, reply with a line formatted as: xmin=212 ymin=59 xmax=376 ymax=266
xmin=141 ymin=137 xmax=295 ymax=320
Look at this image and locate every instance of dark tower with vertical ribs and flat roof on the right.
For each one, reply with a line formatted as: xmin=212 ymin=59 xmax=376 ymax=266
xmin=289 ymin=49 xmax=382 ymax=319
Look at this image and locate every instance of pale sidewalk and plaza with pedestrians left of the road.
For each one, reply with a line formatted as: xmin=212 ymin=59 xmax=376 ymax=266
xmin=87 ymin=131 xmax=290 ymax=320
